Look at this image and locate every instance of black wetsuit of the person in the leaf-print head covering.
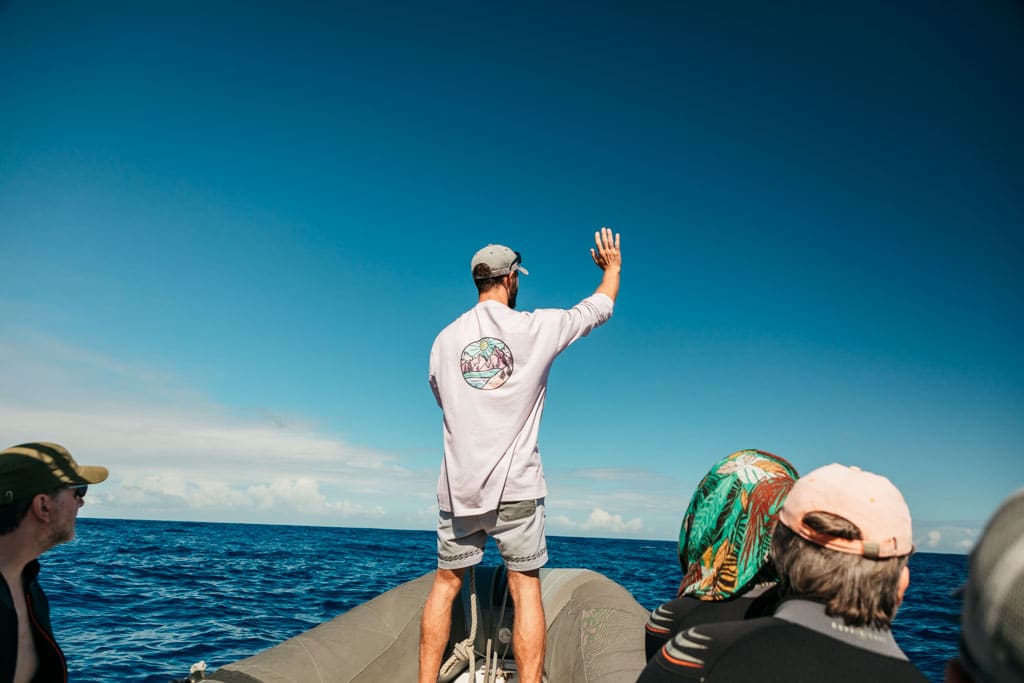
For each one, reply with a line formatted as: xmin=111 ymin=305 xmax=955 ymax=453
xmin=644 ymin=584 xmax=778 ymax=659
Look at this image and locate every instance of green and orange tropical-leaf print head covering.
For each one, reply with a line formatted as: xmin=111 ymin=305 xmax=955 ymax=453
xmin=679 ymin=451 xmax=798 ymax=600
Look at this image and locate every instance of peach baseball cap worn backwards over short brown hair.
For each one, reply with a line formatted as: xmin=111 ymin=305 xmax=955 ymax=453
xmin=778 ymin=463 xmax=913 ymax=559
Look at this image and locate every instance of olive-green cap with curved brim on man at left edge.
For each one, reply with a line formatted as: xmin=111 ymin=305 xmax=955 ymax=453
xmin=0 ymin=441 xmax=108 ymax=505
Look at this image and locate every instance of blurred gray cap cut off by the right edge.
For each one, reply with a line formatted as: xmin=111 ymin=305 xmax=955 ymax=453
xmin=959 ymin=488 xmax=1024 ymax=683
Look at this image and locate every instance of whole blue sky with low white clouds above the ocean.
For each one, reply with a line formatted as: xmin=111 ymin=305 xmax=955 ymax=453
xmin=0 ymin=0 xmax=1024 ymax=551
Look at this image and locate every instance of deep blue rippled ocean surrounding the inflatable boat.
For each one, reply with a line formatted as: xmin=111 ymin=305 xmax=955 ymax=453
xmin=40 ymin=519 xmax=967 ymax=683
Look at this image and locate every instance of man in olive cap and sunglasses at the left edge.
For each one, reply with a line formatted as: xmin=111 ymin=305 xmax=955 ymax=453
xmin=0 ymin=442 xmax=108 ymax=683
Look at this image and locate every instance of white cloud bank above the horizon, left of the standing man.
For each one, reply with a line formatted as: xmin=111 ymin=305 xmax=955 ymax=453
xmin=0 ymin=338 xmax=436 ymax=527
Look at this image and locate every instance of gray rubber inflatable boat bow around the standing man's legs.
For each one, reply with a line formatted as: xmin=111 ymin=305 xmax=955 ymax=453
xmin=206 ymin=567 xmax=647 ymax=683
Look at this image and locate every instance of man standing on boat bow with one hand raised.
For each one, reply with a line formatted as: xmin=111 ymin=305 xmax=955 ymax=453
xmin=420 ymin=227 xmax=622 ymax=683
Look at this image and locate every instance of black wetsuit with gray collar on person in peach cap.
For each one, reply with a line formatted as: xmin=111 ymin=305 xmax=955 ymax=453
xmin=638 ymin=600 xmax=928 ymax=683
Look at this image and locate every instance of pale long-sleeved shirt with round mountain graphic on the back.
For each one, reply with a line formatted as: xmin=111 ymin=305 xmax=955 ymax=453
xmin=430 ymin=294 xmax=614 ymax=517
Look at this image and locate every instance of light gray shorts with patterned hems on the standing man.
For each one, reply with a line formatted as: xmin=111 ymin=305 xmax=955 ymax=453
xmin=437 ymin=498 xmax=548 ymax=571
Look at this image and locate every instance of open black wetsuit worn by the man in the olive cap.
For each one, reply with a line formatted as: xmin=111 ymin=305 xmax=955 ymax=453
xmin=0 ymin=560 xmax=68 ymax=683
